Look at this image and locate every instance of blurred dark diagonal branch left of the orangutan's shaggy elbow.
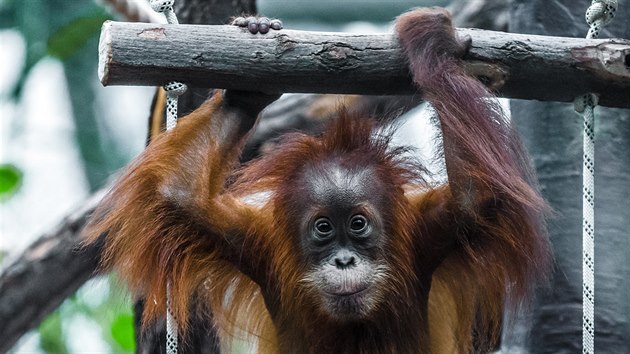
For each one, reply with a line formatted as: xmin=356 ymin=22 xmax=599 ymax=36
xmin=0 ymin=191 xmax=104 ymax=353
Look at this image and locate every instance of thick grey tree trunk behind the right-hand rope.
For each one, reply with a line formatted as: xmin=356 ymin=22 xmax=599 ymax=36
xmin=504 ymin=0 xmax=630 ymax=354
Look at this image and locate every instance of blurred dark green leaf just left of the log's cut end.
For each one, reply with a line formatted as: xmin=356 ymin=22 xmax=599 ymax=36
xmin=47 ymin=13 xmax=111 ymax=60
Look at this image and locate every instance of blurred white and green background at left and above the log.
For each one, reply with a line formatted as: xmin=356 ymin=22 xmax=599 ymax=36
xmin=0 ymin=0 xmax=448 ymax=353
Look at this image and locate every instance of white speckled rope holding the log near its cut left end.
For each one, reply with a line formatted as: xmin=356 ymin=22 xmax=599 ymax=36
xmin=150 ymin=0 xmax=187 ymax=354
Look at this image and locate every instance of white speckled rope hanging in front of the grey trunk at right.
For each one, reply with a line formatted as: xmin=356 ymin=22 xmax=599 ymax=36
xmin=575 ymin=0 xmax=617 ymax=354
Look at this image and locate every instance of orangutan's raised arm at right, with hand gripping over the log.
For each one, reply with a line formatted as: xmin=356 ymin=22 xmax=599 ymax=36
xmin=396 ymin=9 xmax=550 ymax=352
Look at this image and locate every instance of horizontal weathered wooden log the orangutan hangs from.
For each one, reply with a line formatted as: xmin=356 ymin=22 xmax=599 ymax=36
xmin=99 ymin=21 xmax=630 ymax=108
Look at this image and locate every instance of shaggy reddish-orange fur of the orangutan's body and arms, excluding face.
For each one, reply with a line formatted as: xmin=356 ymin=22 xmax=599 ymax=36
xmin=82 ymin=9 xmax=549 ymax=353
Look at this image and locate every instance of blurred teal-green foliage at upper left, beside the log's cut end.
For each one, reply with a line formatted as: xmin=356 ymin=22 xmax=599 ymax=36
xmin=0 ymin=0 xmax=121 ymax=191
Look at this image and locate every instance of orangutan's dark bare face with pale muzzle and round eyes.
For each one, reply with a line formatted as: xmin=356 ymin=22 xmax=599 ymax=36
xmin=301 ymin=162 xmax=388 ymax=321
